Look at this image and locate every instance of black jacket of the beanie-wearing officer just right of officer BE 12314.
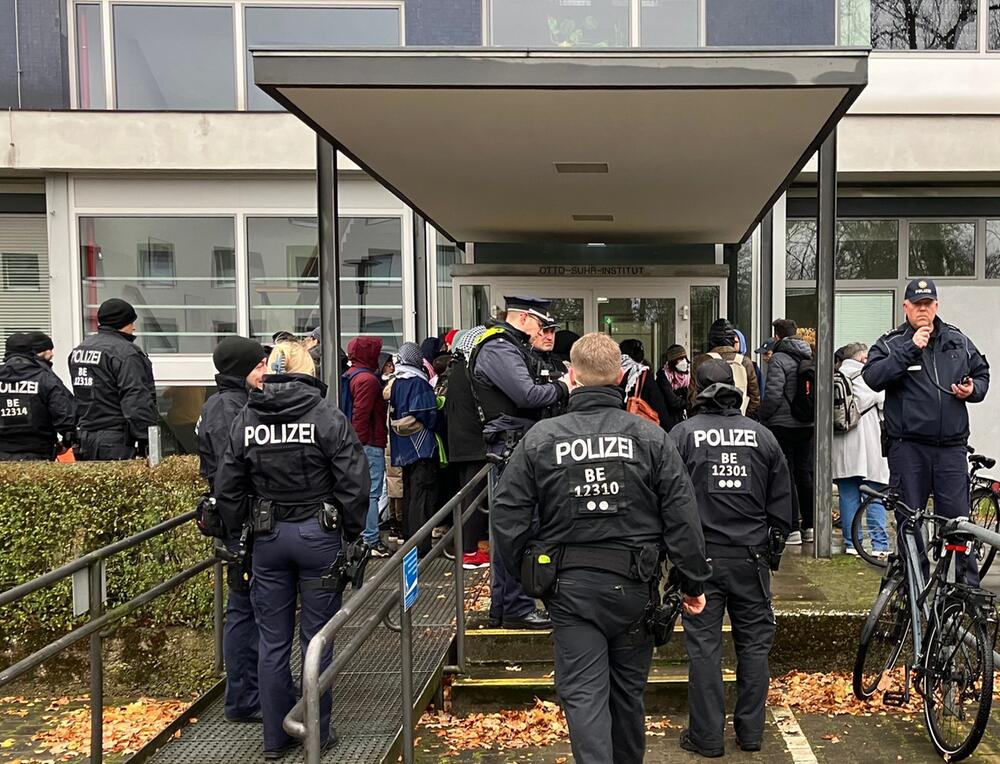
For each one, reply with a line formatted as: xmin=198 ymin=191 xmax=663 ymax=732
xmin=69 ymin=326 xmax=158 ymax=440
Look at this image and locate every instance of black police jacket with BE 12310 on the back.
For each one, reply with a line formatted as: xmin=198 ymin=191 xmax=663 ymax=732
xmin=490 ymin=386 xmax=711 ymax=595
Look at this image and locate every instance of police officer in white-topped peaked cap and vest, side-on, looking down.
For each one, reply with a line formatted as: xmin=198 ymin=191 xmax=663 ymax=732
xmin=468 ymin=297 xmax=569 ymax=629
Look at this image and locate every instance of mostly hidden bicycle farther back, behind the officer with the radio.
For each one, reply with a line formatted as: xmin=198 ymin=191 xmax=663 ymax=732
xmin=851 ymin=447 xmax=1000 ymax=580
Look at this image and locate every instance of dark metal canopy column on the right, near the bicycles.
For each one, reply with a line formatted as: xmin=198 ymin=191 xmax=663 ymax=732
xmin=813 ymin=129 xmax=837 ymax=559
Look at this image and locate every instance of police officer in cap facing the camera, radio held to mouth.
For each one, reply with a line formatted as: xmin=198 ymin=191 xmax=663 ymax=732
xmin=862 ymin=279 xmax=990 ymax=585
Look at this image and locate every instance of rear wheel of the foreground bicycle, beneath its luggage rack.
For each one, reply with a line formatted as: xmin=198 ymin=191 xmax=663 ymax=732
xmin=923 ymin=603 xmax=993 ymax=761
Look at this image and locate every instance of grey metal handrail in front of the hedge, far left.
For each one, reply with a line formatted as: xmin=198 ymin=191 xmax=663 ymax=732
xmin=0 ymin=511 xmax=223 ymax=764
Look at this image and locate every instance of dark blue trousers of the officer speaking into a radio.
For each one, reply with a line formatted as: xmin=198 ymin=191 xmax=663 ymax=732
xmin=889 ymin=440 xmax=979 ymax=586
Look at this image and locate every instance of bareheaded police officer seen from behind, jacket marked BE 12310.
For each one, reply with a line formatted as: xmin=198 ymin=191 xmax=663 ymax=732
xmin=491 ymin=332 xmax=711 ymax=764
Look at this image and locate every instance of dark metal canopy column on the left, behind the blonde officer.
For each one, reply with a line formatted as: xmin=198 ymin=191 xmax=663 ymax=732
xmin=316 ymin=135 xmax=340 ymax=404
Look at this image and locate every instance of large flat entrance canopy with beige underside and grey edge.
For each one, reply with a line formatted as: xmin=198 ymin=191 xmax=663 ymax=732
xmin=253 ymin=48 xmax=868 ymax=243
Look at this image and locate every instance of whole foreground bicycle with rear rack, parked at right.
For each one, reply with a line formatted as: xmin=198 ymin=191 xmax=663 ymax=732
xmin=853 ymin=487 xmax=1000 ymax=761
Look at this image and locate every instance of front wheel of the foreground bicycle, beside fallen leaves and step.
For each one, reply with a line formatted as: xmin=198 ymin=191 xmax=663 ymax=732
xmin=853 ymin=576 xmax=910 ymax=700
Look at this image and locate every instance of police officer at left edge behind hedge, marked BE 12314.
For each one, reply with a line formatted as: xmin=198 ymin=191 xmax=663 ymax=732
xmin=0 ymin=332 xmax=76 ymax=462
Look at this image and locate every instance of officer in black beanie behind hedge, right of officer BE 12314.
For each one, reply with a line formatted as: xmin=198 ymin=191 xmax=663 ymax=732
xmin=69 ymin=297 xmax=157 ymax=461
